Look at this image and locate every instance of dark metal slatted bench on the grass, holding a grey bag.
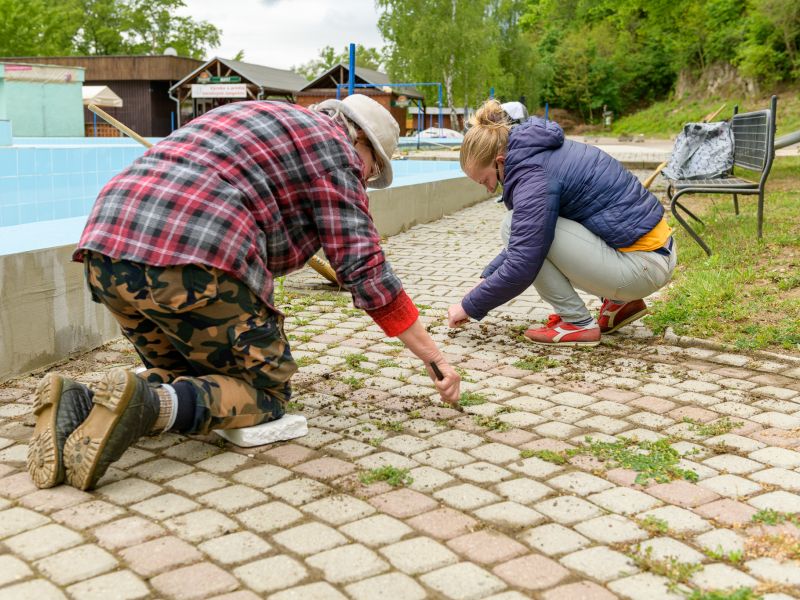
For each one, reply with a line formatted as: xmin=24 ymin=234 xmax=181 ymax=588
xmin=667 ymin=96 xmax=778 ymax=256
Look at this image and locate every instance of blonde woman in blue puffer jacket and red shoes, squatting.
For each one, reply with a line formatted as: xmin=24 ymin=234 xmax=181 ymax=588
xmin=448 ymin=100 xmax=677 ymax=346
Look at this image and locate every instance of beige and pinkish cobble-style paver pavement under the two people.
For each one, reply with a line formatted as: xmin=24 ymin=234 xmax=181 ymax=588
xmin=0 ymin=196 xmax=800 ymax=600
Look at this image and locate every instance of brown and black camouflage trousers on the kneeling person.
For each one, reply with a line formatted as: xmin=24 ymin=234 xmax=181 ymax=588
xmin=84 ymin=252 xmax=297 ymax=433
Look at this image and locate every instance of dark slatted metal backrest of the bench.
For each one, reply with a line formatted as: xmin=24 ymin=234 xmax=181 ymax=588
xmin=731 ymin=96 xmax=778 ymax=183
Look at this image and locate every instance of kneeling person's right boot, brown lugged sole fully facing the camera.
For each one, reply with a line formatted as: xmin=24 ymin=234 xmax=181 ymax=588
xmin=64 ymin=367 xmax=160 ymax=490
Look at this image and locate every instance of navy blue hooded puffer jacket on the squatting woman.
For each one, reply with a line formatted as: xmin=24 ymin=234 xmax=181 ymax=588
xmin=461 ymin=117 xmax=664 ymax=320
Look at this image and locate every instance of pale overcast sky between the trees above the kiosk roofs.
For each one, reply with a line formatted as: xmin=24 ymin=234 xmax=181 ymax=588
xmin=180 ymin=0 xmax=383 ymax=69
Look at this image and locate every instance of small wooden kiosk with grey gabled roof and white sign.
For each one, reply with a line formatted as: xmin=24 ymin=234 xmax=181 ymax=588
xmin=169 ymin=58 xmax=308 ymax=126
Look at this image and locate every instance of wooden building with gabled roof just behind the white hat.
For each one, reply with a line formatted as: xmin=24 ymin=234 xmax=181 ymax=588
xmin=295 ymin=63 xmax=425 ymax=135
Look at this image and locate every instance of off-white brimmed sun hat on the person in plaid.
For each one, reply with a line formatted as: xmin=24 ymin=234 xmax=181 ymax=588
xmin=316 ymin=94 xmax=400 ymax=188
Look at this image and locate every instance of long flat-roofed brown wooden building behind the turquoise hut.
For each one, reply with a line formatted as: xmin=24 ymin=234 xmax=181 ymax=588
xmin=0 ymin=56 xmax=203 ymax=137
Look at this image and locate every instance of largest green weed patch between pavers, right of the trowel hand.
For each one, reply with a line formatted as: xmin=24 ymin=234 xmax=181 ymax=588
xmin=520 ymin=437 xmax=698 ymax=485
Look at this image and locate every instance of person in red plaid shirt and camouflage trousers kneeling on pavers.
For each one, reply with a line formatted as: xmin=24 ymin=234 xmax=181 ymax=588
xmin=28 ymin=94 xmax=460 ymax=489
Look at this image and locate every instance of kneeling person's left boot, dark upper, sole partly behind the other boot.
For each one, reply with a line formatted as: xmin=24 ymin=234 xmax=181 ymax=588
xmin=28 ymin=373 xmax=93 ymax=488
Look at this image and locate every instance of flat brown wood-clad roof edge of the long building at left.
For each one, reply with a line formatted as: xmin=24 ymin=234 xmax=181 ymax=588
xmin=0 ymin=56 xmax=203 ymax=81
